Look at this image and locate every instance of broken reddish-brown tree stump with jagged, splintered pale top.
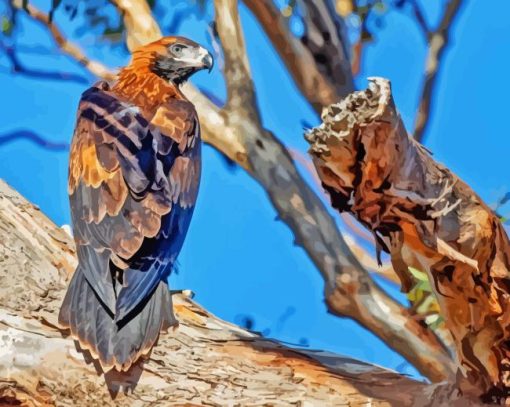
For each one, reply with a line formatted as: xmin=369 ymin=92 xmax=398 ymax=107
xmin=307 ymin=78 xmax=510 ymax=401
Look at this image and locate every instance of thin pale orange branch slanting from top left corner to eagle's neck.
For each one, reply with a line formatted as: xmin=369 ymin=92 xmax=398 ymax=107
xmin=12 ymin=0 xmax=115 ymax=80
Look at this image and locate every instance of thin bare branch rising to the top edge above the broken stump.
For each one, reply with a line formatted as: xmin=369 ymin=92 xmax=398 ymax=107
xmin=413 ymin=0 xmax=464 ymax=142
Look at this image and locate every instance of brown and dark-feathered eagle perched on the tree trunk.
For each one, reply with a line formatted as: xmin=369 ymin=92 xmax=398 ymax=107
xmin=59 ymin=37 xmax=213 ymax=371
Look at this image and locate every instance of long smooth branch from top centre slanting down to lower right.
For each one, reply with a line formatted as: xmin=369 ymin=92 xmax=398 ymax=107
xmin=215 ymin=0 xmax=449 ymax=380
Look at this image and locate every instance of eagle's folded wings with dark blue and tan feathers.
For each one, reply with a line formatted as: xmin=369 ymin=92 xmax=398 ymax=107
xmin=68 ymin=82 xmax=200 ymax=321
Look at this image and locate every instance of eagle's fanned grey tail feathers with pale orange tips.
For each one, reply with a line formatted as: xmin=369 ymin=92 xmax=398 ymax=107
xmin=59 ymin=267 xmax=177 ymax=371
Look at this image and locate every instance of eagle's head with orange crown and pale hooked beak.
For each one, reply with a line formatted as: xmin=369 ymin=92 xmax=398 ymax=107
xmin=133 ymin=37 xmax=214 ymax=85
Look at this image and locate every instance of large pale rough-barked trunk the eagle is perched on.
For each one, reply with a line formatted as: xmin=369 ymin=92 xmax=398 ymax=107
xmin=0 ymin=181 xmax=425 ymax=406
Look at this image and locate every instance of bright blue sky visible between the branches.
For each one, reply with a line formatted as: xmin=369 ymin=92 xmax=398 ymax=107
xmin=0 ymin=0 xmax=510 ymax=377
